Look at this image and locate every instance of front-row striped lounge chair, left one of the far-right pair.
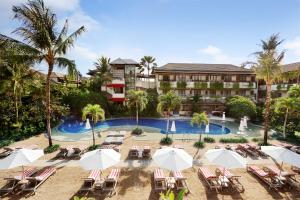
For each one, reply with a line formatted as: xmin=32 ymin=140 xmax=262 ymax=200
xmin=247 ymin=165 xmax=283 ymax=190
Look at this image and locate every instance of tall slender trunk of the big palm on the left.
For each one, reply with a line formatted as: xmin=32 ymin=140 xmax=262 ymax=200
xmin=46 ymin=63 xmax=53 ymax=147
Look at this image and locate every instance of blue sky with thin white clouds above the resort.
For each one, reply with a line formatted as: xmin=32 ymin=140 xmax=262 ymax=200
xmin=0 ymin=0 xmax=300 ymax=75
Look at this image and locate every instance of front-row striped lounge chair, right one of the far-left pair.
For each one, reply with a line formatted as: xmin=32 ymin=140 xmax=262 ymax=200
xmin=22 ymin=167 xmax=56 ymax=193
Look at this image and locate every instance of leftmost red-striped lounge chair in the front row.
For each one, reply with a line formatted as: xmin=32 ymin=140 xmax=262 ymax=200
xmin=0 ymin=168 xmax=37 ymax=194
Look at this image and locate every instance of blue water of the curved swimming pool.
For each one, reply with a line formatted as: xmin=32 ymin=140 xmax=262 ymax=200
xmin=58 ymin=118 xmax=230 ymax=135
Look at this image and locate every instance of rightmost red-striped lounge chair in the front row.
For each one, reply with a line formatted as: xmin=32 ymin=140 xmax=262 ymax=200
xmin=264 ymin=165 xmax=300 ymax=190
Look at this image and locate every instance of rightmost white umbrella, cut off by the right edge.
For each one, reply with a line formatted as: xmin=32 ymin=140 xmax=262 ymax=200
xmin=261 ymin=146 xmax=300 ymax=167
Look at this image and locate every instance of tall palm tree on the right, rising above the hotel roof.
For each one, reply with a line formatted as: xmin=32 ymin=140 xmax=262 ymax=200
xmin=253 ymin=34 xmax=284 ymax=145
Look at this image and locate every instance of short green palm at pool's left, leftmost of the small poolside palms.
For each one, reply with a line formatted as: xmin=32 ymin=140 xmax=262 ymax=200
xmin=82 ymin=104 xmax=105 ymax=146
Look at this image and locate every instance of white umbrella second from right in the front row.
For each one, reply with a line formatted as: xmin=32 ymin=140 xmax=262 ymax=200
xmin=205 ymin=149 xmax=247 ymax=169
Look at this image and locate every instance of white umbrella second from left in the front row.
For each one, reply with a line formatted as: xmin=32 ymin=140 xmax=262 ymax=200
xmin=79 ymin=149 xmax=121 ymax=170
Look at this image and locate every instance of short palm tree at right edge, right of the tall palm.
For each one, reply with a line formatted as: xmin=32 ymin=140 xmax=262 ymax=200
xmin=275 ymin=97 xmax=300 ymax=138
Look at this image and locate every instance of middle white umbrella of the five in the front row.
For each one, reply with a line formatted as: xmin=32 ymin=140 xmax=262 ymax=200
xmin=153 ymin=147 xmax=193 ymax=171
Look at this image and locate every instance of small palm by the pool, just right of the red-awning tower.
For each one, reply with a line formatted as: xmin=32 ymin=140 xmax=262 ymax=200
xmin=127 ymin=90 xmax=148 ymax=126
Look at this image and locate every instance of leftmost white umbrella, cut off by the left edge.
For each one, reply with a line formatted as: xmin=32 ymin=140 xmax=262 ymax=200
xmin=0 ymin=149 xmax=44 ymax=169
